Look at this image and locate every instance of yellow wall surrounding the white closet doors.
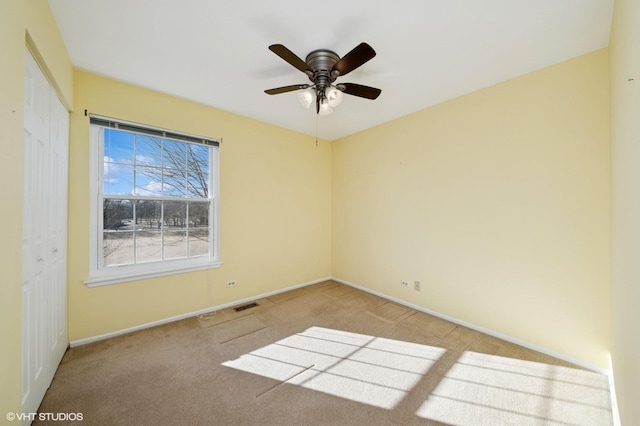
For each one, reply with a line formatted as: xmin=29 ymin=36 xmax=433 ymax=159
xmin=0 ymin=0 xmax=73 ymax=419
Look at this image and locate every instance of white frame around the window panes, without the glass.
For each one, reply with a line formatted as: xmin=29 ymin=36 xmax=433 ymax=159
xmin=85 ymin=114 xmax=222 ymax=287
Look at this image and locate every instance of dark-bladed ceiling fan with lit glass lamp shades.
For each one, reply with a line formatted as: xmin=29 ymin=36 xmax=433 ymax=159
xmin=265 ymin=43 xmax=382 ymax=115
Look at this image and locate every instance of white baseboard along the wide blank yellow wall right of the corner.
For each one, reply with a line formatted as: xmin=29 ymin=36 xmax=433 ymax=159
xmin=331 ymin=277 xmax=609 ymax=375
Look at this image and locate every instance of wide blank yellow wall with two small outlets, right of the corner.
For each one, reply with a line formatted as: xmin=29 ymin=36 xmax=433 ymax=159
xmin=332 ymin=50 xmax=611 ymax=367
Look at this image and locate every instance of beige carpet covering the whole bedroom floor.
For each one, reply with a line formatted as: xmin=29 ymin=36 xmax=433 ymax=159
xmin=35 ymin=281 xmax=612 ymax=426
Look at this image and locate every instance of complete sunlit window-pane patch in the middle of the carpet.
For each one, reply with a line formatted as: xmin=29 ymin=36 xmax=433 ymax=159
xmin=222 ymin=327 xmax=446 ymax=409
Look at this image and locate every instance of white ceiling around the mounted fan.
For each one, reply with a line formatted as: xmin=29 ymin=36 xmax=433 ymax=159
xmin=49 ymin=0 xmax=613 ymax=140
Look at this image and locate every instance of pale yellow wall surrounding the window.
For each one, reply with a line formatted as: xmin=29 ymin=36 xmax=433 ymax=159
xmin=69 ymin=71 xmax=331 ymax=341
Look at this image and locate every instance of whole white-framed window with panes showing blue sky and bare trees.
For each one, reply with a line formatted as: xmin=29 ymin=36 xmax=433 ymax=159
xmin=87 ymin=116 xmax=220 ymax=286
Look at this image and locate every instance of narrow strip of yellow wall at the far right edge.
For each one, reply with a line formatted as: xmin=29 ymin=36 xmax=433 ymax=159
xmin=610 ymin=0 xmax=640 ymax=425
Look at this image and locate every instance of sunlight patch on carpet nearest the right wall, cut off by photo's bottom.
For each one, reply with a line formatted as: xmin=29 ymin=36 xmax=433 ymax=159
xmin=416 ymin=351 xmax=612 ymax=425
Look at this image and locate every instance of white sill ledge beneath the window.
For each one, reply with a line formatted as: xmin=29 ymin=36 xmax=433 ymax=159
xmin=84 ymin=261 xmax=222 ymax=287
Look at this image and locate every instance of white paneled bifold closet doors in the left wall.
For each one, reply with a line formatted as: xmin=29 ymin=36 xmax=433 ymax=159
xmin=22 ymin=51 xmax=69 ymax=413
